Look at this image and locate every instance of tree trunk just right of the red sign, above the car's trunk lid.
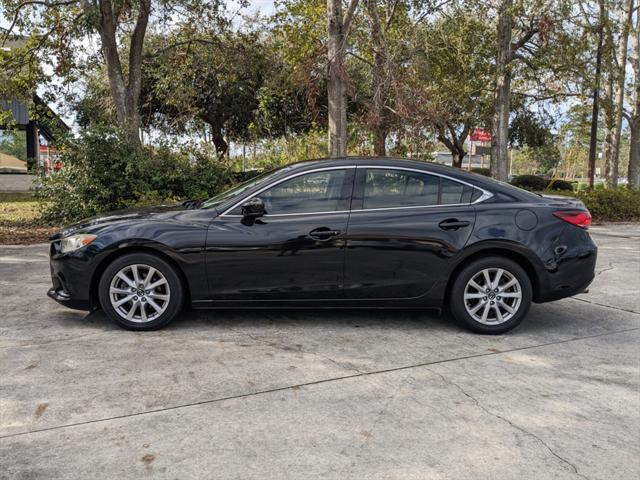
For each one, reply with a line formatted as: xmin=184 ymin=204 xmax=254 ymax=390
xmin=491 ymin=0 xmax=513 ymax=181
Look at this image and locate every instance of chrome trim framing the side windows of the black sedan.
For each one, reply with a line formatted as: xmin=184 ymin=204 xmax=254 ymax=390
xmin=220 ymin=165 xmax=493 ymax=218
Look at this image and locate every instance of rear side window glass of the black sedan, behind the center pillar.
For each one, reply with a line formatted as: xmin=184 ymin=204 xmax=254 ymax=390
xmin=362 ymin=168 xmax=473 ymax=209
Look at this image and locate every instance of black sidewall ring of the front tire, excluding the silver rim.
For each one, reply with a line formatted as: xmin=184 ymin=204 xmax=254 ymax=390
xmin=98 ymin=253 xmax=184 ymax=330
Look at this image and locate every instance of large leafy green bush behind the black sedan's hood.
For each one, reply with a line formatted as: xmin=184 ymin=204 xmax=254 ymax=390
xmin=36 ymin=127 xmax=231 ymax=224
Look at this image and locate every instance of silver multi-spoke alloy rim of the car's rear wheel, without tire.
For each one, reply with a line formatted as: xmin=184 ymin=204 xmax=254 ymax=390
xmin=464 ymin=268 xmax=522 ymax=325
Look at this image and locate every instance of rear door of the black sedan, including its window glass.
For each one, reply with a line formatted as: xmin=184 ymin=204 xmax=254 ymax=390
xmin=345 ymin=167 xmax=475 ymax=299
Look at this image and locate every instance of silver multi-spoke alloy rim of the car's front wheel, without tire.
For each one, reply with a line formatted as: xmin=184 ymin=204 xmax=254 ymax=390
xmin=109 ymin=264 xmax=171 ymax=323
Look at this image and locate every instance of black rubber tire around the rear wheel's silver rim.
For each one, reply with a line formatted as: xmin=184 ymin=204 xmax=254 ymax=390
xmin=448 ymin=256 xmax=532 ymax=335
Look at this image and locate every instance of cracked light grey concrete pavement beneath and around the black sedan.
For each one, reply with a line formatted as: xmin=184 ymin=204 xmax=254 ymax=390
xmin=0 ymin=224 xmax=640 ymax=480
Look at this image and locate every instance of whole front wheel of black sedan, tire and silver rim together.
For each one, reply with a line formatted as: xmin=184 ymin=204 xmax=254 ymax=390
xmin=98 ymin=253 xmax=184 ymax=330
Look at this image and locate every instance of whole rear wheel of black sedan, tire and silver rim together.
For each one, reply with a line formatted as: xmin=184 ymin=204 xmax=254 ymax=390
xmin=449 ymin=256 xmax=532 ymax=334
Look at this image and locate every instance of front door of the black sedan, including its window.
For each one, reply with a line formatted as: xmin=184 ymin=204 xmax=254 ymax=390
xmin=207 ymin=168 xmax=355 ymax=301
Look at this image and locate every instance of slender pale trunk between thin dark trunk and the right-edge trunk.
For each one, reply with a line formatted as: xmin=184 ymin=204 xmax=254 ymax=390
xmin=610 ymin=0 xmax=634 ymax=187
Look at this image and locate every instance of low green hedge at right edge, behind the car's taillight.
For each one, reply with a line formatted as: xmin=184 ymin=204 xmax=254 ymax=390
xmin=575 ymin=187 xmax=640 ymax=221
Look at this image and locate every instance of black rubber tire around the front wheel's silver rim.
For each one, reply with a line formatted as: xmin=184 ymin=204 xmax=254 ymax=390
xmin=98 ymin=253 xmax=184 ymax=330
